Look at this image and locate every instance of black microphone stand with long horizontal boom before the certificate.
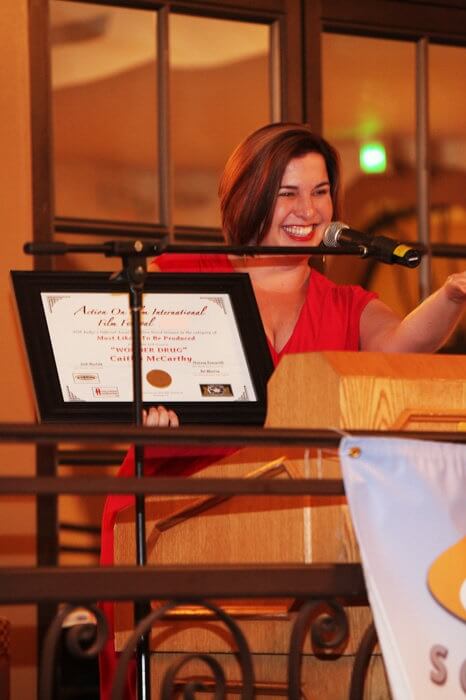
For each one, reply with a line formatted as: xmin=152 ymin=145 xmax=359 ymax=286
xmin=24 ymin=238 xmax=422 ymax=700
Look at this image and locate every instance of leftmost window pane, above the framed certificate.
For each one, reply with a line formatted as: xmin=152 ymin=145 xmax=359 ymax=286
xmin=50 ymin=0 xmax=159 ymax=223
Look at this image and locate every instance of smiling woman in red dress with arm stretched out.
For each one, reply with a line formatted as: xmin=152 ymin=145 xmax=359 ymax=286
xmin=101 ymin=124 xmax=466 ymax=697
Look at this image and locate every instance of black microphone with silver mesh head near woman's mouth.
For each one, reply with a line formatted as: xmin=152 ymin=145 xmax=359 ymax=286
xmin=322 ymin=221 xmax=422 ymax=267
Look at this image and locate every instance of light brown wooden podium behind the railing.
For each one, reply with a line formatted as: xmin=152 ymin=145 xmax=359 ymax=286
xmin=115 ymin=352 xmax=466 ymax=700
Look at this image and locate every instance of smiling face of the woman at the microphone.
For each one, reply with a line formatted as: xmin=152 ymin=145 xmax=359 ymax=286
xmin=261 ymin=153 xmax=333 ymax=246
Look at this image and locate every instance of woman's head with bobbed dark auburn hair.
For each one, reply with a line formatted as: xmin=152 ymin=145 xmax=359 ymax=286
xmin=219 ymin=124 xmax=340 ymax=245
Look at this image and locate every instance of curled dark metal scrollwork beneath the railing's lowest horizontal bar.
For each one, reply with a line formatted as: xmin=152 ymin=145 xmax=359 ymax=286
xmin=35 ymin=599 xmax=377 ymax=700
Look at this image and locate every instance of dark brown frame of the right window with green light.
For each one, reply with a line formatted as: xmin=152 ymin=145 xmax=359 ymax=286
xmin=303 ymin=0 xmax=466 ymax=299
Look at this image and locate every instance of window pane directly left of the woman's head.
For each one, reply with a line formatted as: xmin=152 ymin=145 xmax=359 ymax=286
xmin=170 ymin=14 xmax=271 ymax=227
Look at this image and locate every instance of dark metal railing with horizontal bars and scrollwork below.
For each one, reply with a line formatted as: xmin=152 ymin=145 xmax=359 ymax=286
xmin=0 ymin=424 xmax=452 ymax=700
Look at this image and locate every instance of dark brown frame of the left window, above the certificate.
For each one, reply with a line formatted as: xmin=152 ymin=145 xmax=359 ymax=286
xmin=29 ymin=0 xmax=304 ymax=252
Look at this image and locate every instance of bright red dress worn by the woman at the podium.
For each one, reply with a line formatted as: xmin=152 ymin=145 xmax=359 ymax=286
xmin=100 ymin=254 xmax=377 ymax=700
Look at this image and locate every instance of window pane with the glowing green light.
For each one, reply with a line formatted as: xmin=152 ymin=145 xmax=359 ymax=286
xmin=322 ymin=34 xmax=418 ymax=314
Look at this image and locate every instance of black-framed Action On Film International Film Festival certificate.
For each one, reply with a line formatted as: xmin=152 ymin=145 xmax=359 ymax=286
xmin=11 ymin=271 xmax=273 ymax=424
